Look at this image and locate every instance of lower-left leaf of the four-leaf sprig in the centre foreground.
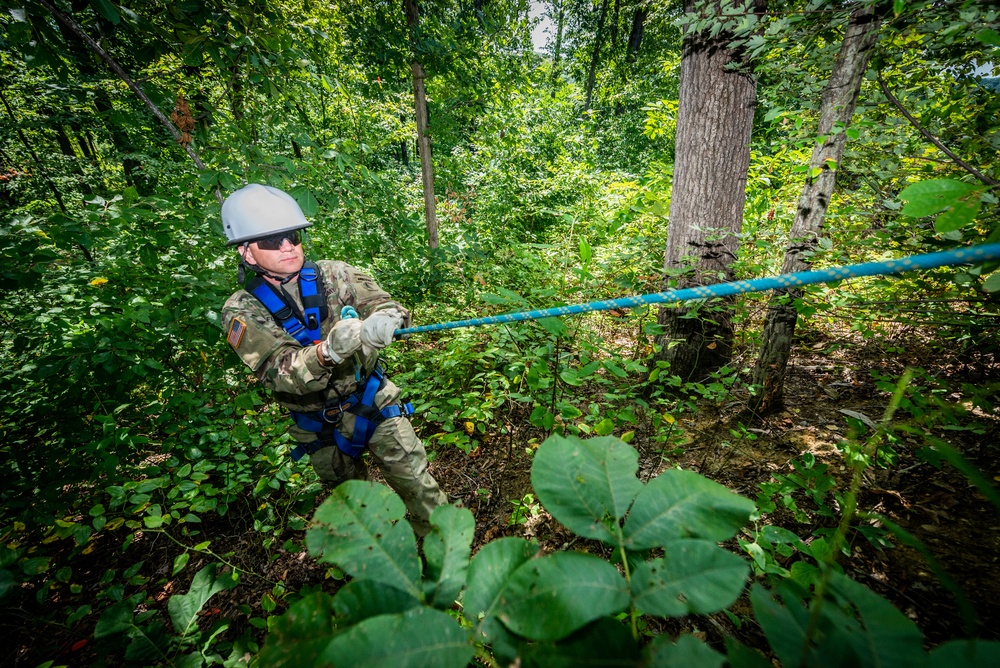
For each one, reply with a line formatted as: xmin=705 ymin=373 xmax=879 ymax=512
xmin=497 ymin=552 xmax=629 ymax=640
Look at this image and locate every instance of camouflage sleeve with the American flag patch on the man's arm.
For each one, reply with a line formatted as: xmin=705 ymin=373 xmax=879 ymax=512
xmin=222 ymin=291 xmax=333 ymax=395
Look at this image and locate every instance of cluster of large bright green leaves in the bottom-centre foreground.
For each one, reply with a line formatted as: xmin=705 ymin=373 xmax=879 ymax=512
xmin=262 ymin=436 xmax=752 ymax=665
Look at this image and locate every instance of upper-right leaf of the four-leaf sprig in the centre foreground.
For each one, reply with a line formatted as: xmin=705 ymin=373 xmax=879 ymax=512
xmin=620 ymin=469 xmax=754 ymax=551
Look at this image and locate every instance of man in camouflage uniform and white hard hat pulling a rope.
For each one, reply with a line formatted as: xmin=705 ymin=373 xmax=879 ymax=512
xmin=222 ymin=184 xmax=447 ymax=535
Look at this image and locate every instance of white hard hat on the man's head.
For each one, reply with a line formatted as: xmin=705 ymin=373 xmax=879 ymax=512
xmin=222 ymin=183 xmax=312 ymax=246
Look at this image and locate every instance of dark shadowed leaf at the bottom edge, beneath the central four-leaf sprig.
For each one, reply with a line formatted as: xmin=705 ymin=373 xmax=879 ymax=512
xmin=524 ymin=617 xmax=640 ymax=668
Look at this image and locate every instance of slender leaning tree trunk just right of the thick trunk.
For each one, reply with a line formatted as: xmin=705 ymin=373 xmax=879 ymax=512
xmin=750 ymin=6 xmax=881 ymax=414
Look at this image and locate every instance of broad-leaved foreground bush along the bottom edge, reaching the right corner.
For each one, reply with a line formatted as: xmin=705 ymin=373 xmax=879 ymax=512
xmin=260 ymin=436 xmax=1000 ymax=667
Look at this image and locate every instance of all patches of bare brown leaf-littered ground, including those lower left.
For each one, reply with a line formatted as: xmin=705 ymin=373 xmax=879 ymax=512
xmin=7 ymin=320 xmax=1000 ymax=666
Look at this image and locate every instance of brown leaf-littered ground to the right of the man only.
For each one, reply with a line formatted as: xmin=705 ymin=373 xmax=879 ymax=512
xmin=424 ymin=324 xmax=1000 ymax=652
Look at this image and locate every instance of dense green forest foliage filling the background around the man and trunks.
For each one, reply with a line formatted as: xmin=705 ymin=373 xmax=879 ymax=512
xmin=0 ymin=0 xmax=1000 ymax=665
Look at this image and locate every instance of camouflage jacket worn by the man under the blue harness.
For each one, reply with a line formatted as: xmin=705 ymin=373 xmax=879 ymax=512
xmin=222 ymin=260 xmax=409 ymax=442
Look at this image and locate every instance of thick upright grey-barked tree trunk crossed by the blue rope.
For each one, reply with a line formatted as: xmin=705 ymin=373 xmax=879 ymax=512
xmin=657 ymin=0 xmax=757 ymax=380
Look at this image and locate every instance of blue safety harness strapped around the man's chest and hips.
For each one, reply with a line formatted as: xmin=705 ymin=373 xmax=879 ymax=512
xmin=249 ymin=262 xmax=414 ymax=462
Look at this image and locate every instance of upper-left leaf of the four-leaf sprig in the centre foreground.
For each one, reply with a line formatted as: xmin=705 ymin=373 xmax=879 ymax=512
xmin=531 ymin=435 xmax=642 ymax=545
